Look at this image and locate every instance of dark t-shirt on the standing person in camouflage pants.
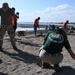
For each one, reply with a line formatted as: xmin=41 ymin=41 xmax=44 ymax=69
xmin=0 ymin=8 xmax=15 ymax=25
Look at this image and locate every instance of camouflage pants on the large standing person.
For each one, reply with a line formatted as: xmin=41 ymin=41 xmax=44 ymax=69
xmin=0 ymin=25 xmax=15 ymax=47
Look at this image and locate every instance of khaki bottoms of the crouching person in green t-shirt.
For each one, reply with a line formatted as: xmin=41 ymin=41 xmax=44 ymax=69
xmin=39 ymin=49 xmax=63 ymax=64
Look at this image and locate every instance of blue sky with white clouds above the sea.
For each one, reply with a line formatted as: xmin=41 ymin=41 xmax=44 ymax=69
xmin=0 ymin=0 xmax=75 ymax=22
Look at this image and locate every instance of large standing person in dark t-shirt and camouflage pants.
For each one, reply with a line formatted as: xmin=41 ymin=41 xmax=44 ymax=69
xmin=0 ymin=3 xmax=16 ymax=50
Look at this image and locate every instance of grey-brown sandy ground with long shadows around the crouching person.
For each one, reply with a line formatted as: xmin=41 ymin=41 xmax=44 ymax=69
xmin=0 ymin=31 xmax=75 ymax=75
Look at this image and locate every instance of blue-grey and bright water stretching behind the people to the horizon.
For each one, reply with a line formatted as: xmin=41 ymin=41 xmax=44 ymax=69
xmin=16 ymin=22 xmax=75 ymax=31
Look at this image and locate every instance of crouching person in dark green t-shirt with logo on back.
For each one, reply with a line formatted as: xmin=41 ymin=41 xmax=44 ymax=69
xmin=39 ymin=29 xmax=75 ymax=71
